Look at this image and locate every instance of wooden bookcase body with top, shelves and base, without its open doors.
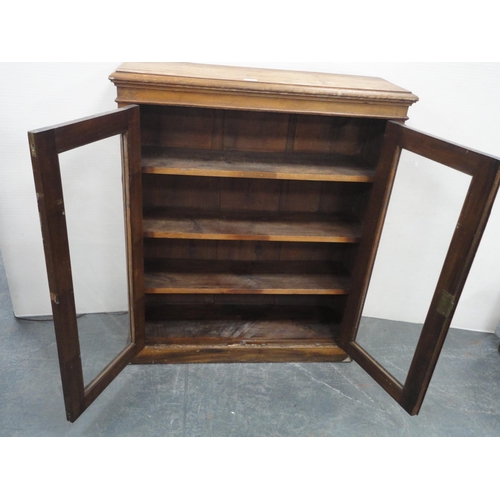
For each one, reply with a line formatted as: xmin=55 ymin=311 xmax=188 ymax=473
xmin=111 ymin=64 xmax=416 ymax=363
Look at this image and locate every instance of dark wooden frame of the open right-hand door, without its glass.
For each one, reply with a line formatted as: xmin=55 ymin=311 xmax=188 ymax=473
xmin=339 ymin=121 xmax=500 ymax=415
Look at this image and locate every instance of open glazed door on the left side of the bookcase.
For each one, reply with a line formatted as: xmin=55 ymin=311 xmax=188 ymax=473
xmin=28 ymin=106 xmax=144 ymax=422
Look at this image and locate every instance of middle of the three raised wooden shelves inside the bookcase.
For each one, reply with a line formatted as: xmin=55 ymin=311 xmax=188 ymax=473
xmin=143 ymin=209 xmax=361 ymax=243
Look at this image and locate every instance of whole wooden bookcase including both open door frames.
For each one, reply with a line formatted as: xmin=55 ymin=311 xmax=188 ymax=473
xmin=29 ymin=63 xmax=500 ymax=420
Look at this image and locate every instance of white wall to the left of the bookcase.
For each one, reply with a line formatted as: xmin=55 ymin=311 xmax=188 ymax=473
xmin=0 ymin=62 xmax=126 ymax=316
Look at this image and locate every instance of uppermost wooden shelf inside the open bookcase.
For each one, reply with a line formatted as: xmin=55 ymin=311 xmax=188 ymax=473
xmin=142 ymin=146 xmax=375 ymax=183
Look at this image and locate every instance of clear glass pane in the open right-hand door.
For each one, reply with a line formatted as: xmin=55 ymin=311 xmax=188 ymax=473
xmin=356 ymin=150 xmax=471 ymax=383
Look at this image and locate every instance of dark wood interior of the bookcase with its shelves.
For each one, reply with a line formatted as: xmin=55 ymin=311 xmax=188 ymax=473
xmin=141 ymin=105 xmax=386 ymax=356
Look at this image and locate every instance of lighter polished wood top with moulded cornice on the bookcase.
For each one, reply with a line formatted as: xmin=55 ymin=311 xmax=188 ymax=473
xmin=110 ymin=62 xmax=418 ymax=120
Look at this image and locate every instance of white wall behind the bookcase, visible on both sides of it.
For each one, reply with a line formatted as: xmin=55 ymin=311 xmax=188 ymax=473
xmin=0 ymin=62 xmax=500 ymax=331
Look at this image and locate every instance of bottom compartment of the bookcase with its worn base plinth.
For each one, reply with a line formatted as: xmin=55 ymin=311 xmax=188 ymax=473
xmin=133 ymin=304 xmax=349 ymax=364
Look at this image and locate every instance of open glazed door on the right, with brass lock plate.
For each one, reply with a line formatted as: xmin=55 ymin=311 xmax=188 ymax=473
xmin=340 ymin=122 xmax=500 ymax=415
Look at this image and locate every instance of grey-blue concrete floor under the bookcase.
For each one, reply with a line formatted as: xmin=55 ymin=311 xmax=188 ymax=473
xmin=0 ymin=252 xmax=500 ymax=437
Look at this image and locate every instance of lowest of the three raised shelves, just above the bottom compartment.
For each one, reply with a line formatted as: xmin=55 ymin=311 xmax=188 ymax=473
xmin=144 ymin=261 xmax=350 ymax=295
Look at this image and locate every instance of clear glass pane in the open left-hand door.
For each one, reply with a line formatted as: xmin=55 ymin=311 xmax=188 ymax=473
xmin=59 ymin=135 xmax=131 ymax=386
